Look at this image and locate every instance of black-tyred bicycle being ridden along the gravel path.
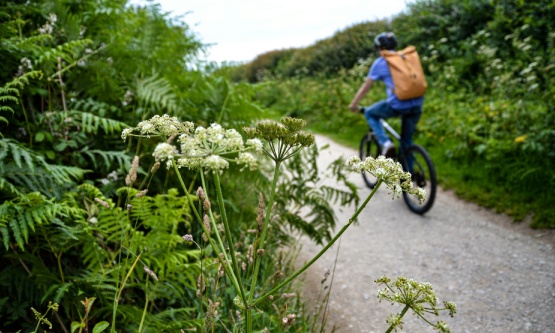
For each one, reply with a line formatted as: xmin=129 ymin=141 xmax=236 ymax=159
xmin=359 ymin=108 xmax=437 ymax=214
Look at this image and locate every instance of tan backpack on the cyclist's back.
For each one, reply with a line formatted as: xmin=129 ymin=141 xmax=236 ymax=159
xmin=381 ymin=46 xmax=428 ymax=100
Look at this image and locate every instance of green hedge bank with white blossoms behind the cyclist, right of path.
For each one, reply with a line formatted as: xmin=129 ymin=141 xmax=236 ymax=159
xmin=233 ymin=0 xmax=555 ymax=228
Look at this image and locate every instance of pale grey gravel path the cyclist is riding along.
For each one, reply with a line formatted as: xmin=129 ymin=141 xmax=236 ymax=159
xmin=298 ymin=136 xmax=555 ymax=333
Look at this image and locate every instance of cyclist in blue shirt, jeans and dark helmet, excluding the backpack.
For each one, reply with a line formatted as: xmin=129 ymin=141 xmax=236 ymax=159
xmin=349 ymin=32 xmax=424 ymax=157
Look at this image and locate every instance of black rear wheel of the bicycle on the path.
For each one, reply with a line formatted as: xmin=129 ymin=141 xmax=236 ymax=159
xmin=403 ymin=145 xmax=437 ymax=214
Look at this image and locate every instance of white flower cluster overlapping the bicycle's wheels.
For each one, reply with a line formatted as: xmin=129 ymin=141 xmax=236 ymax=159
xmin=347 ymin=155 xmax=426 ymax=202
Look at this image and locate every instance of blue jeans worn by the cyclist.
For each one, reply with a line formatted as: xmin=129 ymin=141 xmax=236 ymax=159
xmin=364 ymin=100 xmax=422 ymax=149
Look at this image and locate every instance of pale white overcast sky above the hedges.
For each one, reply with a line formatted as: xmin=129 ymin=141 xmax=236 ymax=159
xmin=130 ymin=0 xmax=413 ymax=63
